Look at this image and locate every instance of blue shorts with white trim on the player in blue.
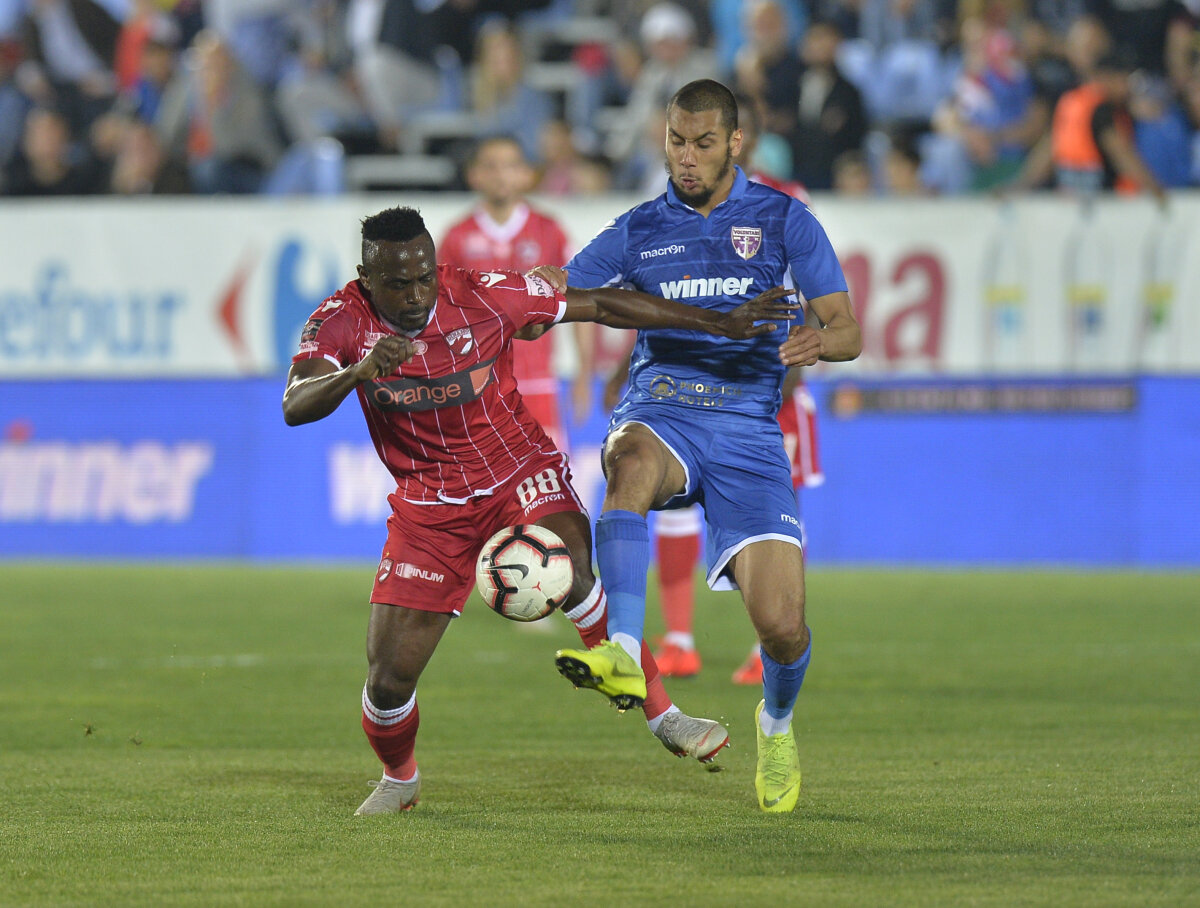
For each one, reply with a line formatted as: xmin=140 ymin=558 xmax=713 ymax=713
xmin=608 ymin=403 xmax=804 ymax=590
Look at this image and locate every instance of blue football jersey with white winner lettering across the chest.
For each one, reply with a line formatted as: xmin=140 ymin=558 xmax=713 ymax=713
xmin=566 ymin=168 xmax=846 ymax=417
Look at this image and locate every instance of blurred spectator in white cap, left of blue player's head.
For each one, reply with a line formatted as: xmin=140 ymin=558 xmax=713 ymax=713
xmin=608 ymin=2 xmax=714 ymax=192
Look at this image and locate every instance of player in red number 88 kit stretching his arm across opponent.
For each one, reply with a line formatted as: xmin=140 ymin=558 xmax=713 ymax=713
xmin=283 ymin=208 xmax=797 ymax=814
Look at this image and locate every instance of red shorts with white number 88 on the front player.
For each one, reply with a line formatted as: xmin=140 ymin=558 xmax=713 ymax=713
xmin=371 ymin=453 xmax=587 ymax=615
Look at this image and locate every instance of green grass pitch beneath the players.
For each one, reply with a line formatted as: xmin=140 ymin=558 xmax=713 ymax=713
xmin=0 ymin=565 xmax=1200 ymax=906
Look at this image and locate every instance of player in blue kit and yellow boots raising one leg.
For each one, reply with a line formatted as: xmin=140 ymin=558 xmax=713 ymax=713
xmin=557 ymin=79 xmax=862 ymax=812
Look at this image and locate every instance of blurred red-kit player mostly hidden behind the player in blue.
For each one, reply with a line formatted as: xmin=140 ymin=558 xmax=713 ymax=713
xmin=619 ymin=96 xmax=824 ymax=685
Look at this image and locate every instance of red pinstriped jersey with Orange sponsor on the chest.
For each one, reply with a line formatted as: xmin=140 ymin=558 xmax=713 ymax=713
xmin=292 ymin=265 xmax=566 ymax=504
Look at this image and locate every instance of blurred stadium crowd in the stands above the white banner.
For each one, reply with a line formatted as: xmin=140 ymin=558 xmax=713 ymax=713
xmin=0 ymin=0 xmax=1200 ymax=196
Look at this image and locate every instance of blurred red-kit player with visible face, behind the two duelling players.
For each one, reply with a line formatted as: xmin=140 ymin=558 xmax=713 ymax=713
xmin=438 ymin=136 xmax=593 ymax=450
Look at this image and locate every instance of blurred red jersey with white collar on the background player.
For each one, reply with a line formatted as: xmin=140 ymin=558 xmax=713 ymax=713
xmin=438 ymin=204 xmax=571 ymax=395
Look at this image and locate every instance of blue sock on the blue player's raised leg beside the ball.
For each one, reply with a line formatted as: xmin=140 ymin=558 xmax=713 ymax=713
xmin=596 ymin=511 xmax=650 ymax=642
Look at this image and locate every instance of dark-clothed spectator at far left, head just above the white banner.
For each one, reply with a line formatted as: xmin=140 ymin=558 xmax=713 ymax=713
xmin=5 ymin=107 xmax=103 ymax=196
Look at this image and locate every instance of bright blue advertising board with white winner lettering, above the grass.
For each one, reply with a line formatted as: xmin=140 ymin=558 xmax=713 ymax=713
xmin=0 ymin=377 xmax=1200 ymax=567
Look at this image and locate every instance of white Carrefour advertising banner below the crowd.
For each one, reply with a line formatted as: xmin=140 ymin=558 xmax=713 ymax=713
xmin=0 ymin=196 xmax=1200 ymax=378
